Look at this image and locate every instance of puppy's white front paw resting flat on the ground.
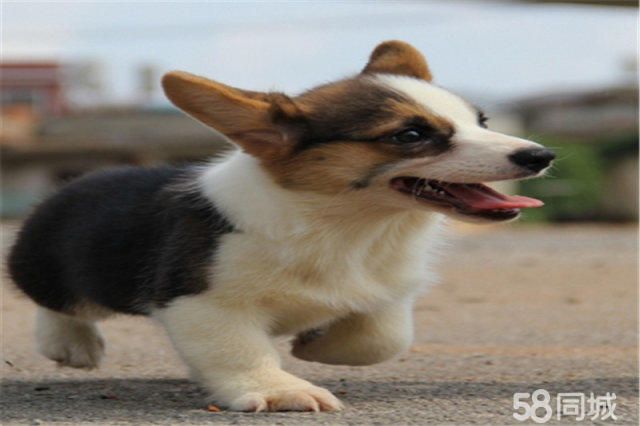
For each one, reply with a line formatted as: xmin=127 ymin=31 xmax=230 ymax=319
xmin=229 ymin=386 xmax=344 ymax=413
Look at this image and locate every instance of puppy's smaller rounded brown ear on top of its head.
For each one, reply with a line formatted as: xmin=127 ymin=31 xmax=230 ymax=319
xmin=362 ymin=40 xmax=433 ymax=81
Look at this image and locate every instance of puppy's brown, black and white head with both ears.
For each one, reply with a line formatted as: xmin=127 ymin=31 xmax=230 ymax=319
xmin=162 ymin=41 xmax=554 ymax=220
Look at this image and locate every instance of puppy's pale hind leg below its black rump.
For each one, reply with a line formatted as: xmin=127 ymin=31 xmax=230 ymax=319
xmin=36 ymin=307 xmax=104 ymax=368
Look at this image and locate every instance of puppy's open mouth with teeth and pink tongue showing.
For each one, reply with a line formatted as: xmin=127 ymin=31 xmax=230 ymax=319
xmin=391 ymin=177 xmax=544 ymax=220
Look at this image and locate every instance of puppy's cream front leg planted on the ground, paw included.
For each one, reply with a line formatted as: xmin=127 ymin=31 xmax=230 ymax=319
xmin=156 ymin=296 xmax=342 ymax=411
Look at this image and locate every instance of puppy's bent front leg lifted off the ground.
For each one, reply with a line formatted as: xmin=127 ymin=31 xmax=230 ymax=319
xmin=291 ymin=301 xmax=413 ymax=365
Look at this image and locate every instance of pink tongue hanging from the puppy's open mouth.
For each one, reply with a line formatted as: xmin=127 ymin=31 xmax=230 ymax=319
xmin=444 ymin=184 xmax=544 ymax=210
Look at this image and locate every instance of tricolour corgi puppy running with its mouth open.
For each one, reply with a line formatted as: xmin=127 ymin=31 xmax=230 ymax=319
xmin=8 ymin=41 xmax=554 ymax=411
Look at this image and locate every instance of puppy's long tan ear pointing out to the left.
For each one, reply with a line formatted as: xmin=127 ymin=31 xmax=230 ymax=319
xmin=162 ymin=71 xmax=304 ymax=158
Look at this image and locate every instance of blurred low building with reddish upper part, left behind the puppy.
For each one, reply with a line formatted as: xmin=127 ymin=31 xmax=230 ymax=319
xmin=0 ymin=63 xmax=226 ymax=218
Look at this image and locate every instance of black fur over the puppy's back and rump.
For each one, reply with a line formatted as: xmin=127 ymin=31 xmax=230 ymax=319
xmin=8 ymin=167 xmax=233 ymax=314
